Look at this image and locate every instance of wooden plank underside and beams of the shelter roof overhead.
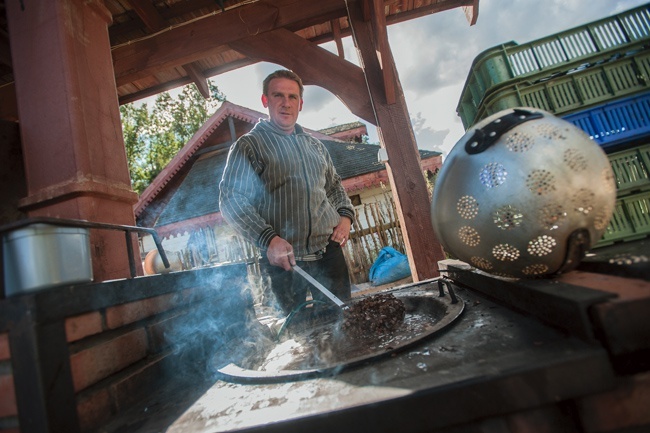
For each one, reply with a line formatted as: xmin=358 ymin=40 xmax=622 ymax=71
xmin=0 ymin=0 xmax=478 ymax=111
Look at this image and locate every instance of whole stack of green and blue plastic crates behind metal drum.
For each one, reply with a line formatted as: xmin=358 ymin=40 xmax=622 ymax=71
xmin=457 ymin=4 xmax=650 ymax=246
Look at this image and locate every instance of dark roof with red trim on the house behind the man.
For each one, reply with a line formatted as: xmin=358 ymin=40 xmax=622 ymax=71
xmin=135 ymin=102 xmax=440 ymax=227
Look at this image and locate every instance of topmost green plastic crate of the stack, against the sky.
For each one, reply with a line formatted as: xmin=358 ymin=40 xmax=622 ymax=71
xmin=456 ymin=4 xmax=650 ymax=129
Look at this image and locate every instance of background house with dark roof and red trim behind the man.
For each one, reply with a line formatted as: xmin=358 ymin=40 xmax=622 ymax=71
xmin=135 ymin=102 xmax=442 ymax=279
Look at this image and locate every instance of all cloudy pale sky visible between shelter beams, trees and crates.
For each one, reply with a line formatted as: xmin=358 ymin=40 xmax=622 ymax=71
xmin=165 ymin=0 xmax=648 ymax=159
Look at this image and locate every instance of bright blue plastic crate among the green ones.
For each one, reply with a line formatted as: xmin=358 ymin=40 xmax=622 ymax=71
xmin=562 ymin=93 xmax=650 ymax=147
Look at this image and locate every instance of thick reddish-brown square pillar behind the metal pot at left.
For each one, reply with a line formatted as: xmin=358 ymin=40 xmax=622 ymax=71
xmin=6 ymin=0 xmax=141 ymax=281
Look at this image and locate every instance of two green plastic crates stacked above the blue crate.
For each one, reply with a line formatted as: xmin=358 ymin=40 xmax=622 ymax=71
xmin=456 ymin=5 xmax=650 ymax=129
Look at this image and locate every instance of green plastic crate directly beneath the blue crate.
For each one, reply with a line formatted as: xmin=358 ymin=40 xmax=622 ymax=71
xmin=608 ymin=144 xmax=650 ymax=196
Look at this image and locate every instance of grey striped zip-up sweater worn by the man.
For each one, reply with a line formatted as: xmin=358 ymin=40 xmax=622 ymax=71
xmin=219 ymin=120 xmax=354 ymax=257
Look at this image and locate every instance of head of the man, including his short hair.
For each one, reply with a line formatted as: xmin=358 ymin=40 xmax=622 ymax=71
xmin=262 ymin=69 xmax=304 ymax=134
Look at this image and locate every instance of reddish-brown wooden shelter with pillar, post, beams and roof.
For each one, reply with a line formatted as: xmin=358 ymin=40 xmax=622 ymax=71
xmin=0 ymin=0 xmax=478 ymax=281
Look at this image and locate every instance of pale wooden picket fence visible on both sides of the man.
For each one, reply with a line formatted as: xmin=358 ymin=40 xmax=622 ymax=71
xmin=175 ymin=192 xmax=404 ymax=284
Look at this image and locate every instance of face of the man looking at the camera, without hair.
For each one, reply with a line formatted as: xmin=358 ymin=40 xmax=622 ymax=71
xmin=262 ymin=78 xmax=302 ymax=134
